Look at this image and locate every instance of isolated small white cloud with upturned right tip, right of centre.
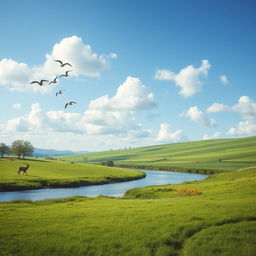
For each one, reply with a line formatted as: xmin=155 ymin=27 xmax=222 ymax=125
xmin=155 ymin=60 xmax=211 ymax=98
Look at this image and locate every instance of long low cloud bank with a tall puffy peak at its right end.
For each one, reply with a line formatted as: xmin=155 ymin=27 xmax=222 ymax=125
xmin=6 ymin=77 xmax=156 ymax=137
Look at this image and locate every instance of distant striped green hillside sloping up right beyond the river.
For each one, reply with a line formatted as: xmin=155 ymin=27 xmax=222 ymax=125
xmin=59 ymin=136 xmax=256 ymax=171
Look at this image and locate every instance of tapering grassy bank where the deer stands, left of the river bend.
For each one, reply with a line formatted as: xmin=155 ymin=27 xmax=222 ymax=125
xmin=0 ymin=158 xmax=144 ymax=191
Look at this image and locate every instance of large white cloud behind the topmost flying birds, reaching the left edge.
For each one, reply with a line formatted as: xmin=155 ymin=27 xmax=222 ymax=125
xmin=0 ymin=36 xmax=117 ymax=93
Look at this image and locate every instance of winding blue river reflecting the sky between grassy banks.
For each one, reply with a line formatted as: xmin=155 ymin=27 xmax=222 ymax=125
xmin=0 ymin=171 xmax=207 ymax=202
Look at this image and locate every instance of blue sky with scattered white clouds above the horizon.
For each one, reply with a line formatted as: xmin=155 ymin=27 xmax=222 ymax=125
xmin=0 ymin=0 xmax=256 ymax=151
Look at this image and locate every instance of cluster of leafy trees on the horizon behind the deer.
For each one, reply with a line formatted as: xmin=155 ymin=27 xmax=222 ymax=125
xmin=0 ymin=140 xmax=35 ymax=159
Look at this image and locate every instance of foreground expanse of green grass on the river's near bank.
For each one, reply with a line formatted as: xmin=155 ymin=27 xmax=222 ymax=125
xmin=0 ymin=169 xmax=256 ymax=256
